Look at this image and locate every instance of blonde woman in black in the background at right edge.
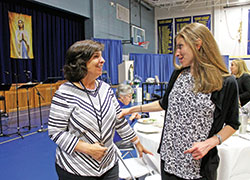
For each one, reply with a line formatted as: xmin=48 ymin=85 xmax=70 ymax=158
xmin=230 ymin=59 xmax=250 ymax=106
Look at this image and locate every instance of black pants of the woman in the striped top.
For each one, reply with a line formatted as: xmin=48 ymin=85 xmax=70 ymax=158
xmin=56 ymin=163 xmax=119 ymax=180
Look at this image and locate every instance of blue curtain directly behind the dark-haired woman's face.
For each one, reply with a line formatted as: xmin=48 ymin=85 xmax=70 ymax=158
xmin=93 ymin=38 xmax=122 ymax=84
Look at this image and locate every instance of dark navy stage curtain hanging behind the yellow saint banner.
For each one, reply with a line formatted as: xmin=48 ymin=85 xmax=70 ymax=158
xmin=0 ymin=0 xmax=84 ymax=83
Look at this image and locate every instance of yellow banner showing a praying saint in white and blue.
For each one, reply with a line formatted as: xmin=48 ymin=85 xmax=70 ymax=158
xmin=8 ymin=12 xmax=34 ymax=59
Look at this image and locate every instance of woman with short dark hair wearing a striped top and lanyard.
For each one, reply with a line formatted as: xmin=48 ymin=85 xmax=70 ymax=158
xmin=48 ymin=40 xmax=150 ymax=180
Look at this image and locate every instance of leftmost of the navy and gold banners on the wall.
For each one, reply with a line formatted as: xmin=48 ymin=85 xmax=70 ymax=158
xmin=158 ymin=19 xmax=173 ymax=54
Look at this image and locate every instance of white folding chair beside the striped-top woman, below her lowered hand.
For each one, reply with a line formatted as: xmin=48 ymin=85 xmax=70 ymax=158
xmin=115 ymin=145 xmax=154 ymax=180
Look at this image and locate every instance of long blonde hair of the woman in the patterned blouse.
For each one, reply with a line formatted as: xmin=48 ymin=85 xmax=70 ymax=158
xmin=173 ymin=23 xmax=229 ymax=93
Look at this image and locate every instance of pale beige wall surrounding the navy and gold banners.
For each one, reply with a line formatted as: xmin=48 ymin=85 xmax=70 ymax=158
xmin=155 ymin=3 xmax=250 ymax=56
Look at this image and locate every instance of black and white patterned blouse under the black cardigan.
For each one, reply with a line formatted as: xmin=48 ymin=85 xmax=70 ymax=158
xmin=160 ymin=69 xmax=215 ymax=179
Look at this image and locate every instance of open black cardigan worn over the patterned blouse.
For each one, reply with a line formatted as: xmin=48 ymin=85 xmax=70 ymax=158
xmin=158 ymin=68 xmax=240 ymax=180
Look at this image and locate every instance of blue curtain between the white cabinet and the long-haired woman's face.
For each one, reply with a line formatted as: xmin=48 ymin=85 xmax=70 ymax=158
xmin=129 ymin=53 xmax=174 ymax=82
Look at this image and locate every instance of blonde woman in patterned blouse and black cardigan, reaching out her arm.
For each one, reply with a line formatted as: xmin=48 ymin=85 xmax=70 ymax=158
xmin=119 ymin=23 xmax=240 ymax=180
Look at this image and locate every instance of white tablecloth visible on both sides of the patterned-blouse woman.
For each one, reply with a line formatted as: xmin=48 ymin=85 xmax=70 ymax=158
xmin=134 ymin=113 xmax=250 ymax=180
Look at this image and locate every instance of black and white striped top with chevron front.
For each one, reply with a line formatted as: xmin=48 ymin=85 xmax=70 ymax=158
xmin=48 ymin=81 xmax=136 ymax=176
